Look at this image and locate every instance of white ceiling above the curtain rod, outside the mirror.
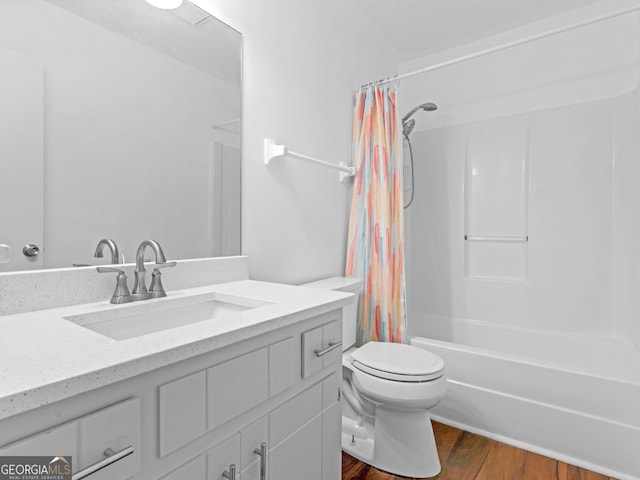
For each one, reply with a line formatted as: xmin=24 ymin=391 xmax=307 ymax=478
xmin=344 ymin=0 xmax=598 ymax=61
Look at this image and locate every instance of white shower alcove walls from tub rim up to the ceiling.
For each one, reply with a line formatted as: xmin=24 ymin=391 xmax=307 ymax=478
xmin=401 ymin=2 xmax=640 ymax=344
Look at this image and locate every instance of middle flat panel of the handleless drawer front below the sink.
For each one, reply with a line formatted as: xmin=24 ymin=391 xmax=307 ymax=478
xmin=207 ymin=348 xmax=269 ymax=430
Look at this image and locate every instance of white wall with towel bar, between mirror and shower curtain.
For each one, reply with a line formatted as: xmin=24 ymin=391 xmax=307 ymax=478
xmin=194 ymin=0 xmax=397 ymax=283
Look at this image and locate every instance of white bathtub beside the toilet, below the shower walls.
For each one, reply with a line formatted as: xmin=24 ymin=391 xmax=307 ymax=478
xmin=410 ymin=318 xmax=640 ymax=479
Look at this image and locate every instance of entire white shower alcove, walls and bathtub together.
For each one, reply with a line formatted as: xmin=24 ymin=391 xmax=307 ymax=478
xmin=400 ymin=9 xmax=640 ymax=479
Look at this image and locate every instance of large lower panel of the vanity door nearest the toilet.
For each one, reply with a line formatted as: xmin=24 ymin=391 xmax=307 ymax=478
xmin=268 ymin=415 xmax=322 ymax=480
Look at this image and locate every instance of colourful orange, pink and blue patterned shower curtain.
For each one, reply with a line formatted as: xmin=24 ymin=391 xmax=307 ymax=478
xmin=345 ymin=86 xmax=406 ymax=345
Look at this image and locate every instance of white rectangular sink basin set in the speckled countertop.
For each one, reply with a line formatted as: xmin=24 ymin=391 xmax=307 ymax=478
xmin=64 ymin=295 xmax=268 ymax=340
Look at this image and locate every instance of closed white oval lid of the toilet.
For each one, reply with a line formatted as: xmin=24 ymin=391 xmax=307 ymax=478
xmin=351 ymin=342 xmax=444 ymax=382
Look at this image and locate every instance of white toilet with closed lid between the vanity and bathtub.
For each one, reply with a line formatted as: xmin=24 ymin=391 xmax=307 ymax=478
xmin=302 ymin=277 xmax=447 ymax=478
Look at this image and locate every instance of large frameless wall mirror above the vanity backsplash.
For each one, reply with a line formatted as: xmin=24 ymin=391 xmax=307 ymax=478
xmin=0 ymin=0 xmax=242 ymax=272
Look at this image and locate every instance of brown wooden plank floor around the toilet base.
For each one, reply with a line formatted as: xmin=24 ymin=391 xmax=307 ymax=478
xmin=342 ymin=422 xmax=615 ymax=480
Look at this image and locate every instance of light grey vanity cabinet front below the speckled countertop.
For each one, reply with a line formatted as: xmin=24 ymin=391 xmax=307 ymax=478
xmin=0 ymin=310 xmax=342 ymax=480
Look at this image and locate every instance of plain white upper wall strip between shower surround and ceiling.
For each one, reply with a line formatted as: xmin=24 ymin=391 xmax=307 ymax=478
xmin=399 ymin=1 xmax=640 ymax=130
